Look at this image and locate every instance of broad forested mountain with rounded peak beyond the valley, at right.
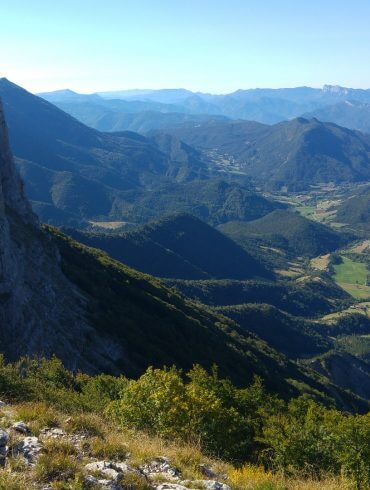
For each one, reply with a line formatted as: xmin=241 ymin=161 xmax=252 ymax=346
xmin=163 ymin=118 xmax=370 ymax=191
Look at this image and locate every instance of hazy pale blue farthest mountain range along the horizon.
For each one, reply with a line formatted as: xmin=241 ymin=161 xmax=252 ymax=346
xmin=39 ymin=85 xmax=370 ymax=126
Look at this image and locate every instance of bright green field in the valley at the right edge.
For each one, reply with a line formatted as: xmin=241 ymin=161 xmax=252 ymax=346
xmin=334 ymin=257 xmax=370 ymax=299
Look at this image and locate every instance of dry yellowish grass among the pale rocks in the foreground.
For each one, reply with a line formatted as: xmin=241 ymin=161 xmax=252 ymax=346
xmin=0 ymin=403 xmax=349 ymax=490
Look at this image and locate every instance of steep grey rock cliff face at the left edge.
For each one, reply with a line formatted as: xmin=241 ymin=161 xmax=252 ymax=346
xmin=0 ymin=102 xmax=121 ymax=371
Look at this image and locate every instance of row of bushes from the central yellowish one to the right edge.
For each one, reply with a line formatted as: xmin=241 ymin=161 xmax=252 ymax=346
xmin=109 ymin=366 xmax=370 ymax=488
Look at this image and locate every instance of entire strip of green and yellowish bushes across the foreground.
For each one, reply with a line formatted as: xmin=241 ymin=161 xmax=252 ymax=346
xmin=0 ymin=358 xmax=370 ymax=489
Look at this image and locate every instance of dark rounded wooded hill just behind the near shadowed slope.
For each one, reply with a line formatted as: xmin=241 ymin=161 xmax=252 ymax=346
xmin=69 ymin=214 xmax=270 ymax=279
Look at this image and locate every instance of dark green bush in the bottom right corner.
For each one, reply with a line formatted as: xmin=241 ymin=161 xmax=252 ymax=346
xmin=263 ymin=397 xmax=370 ymax=488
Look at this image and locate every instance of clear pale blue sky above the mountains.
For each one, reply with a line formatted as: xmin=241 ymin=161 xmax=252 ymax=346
xmin=0 ymin=0 xmax=370 ymax=93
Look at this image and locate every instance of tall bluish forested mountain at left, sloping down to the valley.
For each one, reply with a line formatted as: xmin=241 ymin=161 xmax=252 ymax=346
xmin=0 ymin=79 xmax=290 ymax=225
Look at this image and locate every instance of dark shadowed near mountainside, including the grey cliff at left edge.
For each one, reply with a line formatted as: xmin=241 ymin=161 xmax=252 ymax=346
xmin=0 ymin=97 xmax=366 ymax=408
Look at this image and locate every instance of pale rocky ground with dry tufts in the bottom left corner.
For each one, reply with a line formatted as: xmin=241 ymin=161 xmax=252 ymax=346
xmin=0 ymin=402 xmax=231 ymax=490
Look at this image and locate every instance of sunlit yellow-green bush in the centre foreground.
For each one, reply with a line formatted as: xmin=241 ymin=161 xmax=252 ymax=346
xmin=109 ymin=366 xmax=278 ymax=460
